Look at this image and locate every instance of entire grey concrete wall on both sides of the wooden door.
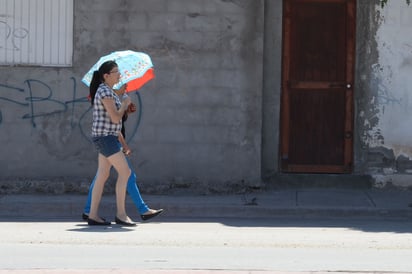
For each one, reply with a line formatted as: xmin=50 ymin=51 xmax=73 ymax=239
xmin=0 ymin=0 xmax=412 ymax=193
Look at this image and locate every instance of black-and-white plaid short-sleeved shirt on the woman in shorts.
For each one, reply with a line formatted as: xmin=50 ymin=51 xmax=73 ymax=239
xmin=92 ymin=83 xmax=122 ymax=137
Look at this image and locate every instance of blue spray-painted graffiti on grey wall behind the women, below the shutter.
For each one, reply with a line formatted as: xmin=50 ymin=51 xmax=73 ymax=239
xmin=0 ymin=77 xmax=142 ymax=140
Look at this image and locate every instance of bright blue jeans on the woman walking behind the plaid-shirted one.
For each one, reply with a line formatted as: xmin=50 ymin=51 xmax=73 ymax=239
xmin=84 ymin=157 xmax=149 ymax=214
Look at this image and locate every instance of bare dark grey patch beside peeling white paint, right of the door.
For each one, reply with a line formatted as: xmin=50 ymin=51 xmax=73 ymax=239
xmin=355 ymin=0 xmax=412 ymax=179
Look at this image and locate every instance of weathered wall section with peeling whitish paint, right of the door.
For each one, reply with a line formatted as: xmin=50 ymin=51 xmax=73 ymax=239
xmin=355 ymin=1 xmax=412 ymax=187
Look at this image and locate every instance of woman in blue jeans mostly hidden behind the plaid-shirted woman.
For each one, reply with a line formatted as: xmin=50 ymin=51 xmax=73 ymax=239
xmin=82 ymin=81 xmax=163 ymax=221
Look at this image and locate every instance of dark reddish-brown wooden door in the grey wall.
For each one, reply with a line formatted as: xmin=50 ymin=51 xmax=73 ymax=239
xmin=280 ymin=0 xmax=356 ymax=173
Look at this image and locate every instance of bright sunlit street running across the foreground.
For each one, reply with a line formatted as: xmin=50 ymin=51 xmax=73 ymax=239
xmin=0 ymin=216 xmax=412 ymax=273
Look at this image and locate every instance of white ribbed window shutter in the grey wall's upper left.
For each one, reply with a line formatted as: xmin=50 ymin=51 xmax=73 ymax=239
xmin=0 ymin=0 xmax=73 ymax=67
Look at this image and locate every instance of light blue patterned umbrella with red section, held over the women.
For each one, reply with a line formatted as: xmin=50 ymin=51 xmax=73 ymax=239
xmin=82 ymin=50 xmax=155 ymax=92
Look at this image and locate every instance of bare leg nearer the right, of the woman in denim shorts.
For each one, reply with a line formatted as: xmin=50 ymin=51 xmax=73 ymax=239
xmin=107 ymin=151 xmax=131 ymax=222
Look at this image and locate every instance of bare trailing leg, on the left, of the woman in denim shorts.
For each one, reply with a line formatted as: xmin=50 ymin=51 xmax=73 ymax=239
xmin=89 ymin=153 xmax=111 ymax=222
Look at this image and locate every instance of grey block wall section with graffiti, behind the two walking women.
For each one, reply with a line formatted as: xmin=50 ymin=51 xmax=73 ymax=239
xmin=0 ymin=0 xmax=263 ymax=192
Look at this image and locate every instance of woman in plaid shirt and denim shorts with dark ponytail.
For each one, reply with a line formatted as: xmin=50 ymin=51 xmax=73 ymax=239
xmin=88 ymin=61 xmax=136 ymax=226
